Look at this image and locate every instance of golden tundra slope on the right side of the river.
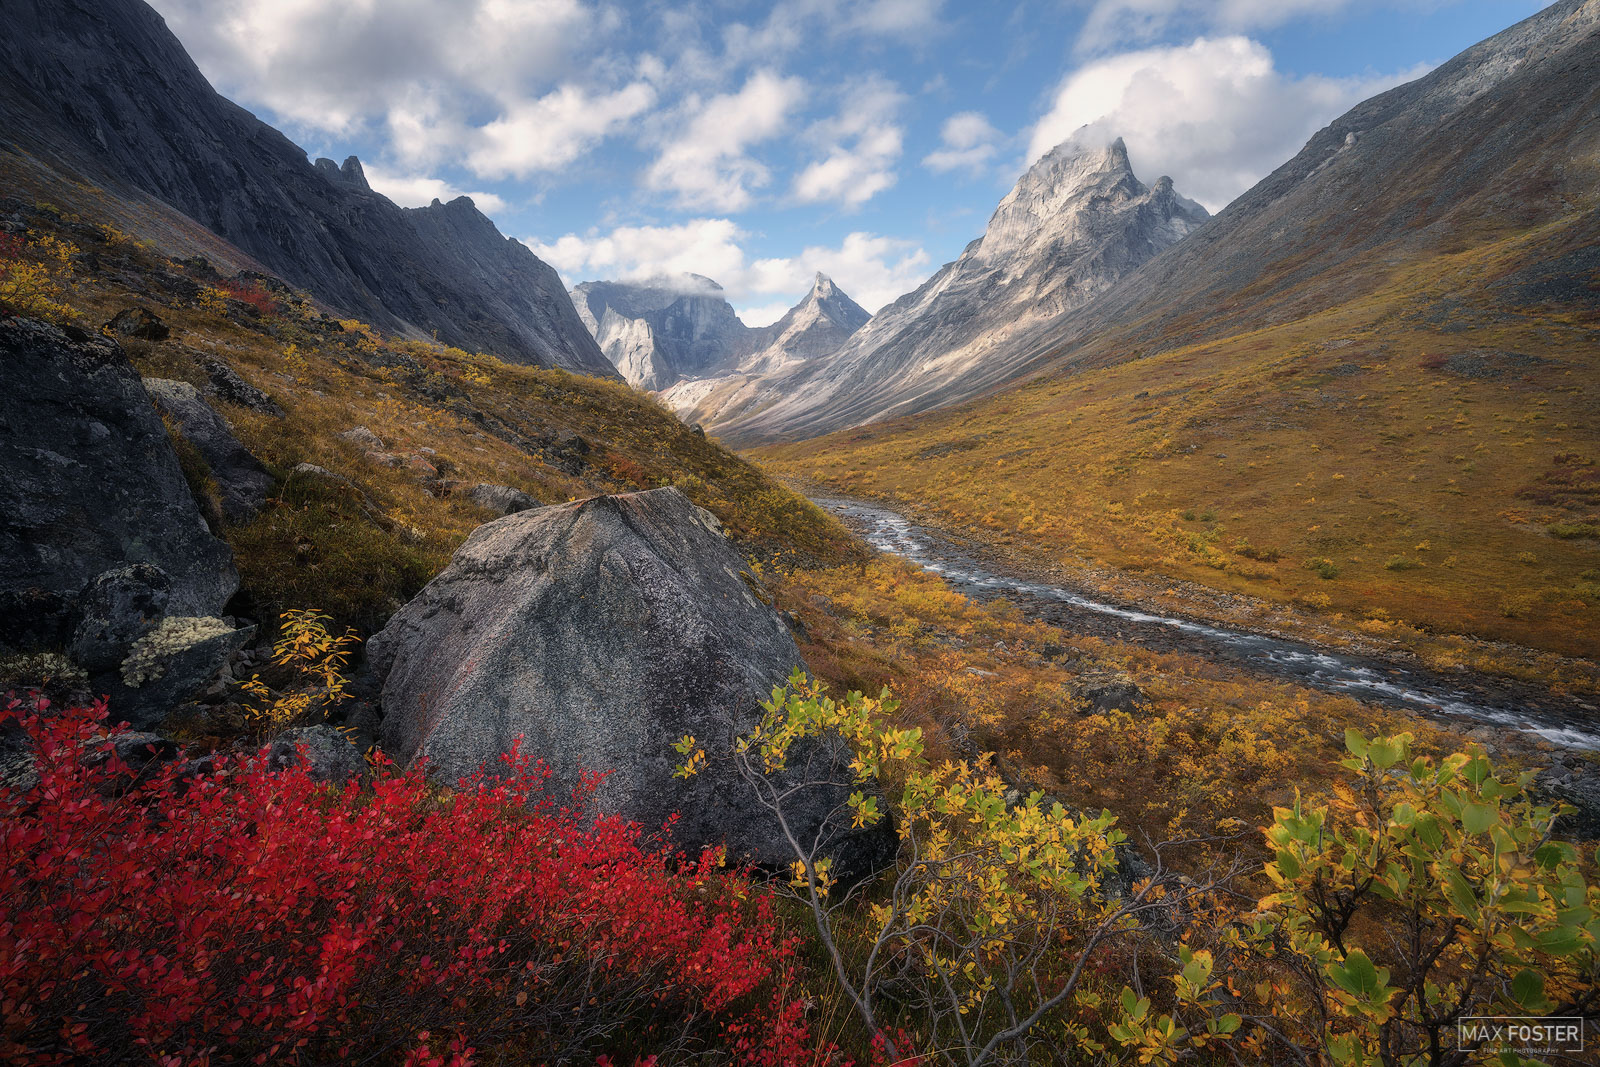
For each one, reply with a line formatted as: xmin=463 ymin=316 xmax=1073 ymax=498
xmin=754 ymin=220 xmax=1600 ymax=693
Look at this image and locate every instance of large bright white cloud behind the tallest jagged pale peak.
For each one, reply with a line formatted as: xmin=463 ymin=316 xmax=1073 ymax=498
xmin=1027 ymin=37 xmax=1424 ymax=211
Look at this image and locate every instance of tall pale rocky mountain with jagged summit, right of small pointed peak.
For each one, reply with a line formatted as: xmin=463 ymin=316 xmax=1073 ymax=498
xmin=717 ymin=139 xmax=1208 ymax=442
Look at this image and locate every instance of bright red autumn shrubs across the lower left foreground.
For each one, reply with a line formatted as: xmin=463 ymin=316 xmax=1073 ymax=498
xmin=0 ymin=701 xmax=826 ymax=1067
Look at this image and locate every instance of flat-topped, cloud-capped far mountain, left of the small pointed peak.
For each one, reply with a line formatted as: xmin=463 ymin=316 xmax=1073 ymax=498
xmin=571 ymin=275 xmax=750 ymax=389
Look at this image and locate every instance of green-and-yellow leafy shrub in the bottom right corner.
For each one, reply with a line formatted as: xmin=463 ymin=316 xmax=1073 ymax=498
xmin=1256 ymin=731 xmax=1600 ymax=1067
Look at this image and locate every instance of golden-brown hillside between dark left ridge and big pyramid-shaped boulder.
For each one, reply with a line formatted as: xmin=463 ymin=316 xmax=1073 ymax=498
xmin=8 ymin=192 xmax=859 ymax=630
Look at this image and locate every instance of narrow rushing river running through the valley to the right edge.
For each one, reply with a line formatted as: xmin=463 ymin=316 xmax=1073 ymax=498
xmin=814 ymin=498 xmax=1600 ymax=750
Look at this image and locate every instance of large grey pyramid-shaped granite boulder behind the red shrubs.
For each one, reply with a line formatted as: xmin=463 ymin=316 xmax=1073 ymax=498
xmin=368 ymin=488 xmax=894 ymax=872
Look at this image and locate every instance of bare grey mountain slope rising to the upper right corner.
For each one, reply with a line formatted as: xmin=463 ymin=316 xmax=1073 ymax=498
xmin=921 ymin=0 xmax=1600 ymax=398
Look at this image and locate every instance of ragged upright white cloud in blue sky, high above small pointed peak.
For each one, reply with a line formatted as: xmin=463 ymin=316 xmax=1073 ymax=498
xmin=794 ymin=78 xmax=906 ymax=208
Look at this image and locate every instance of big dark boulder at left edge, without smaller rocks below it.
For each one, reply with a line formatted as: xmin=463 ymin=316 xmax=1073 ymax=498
xmin=0 ymin=318 xmax=238 ymax=651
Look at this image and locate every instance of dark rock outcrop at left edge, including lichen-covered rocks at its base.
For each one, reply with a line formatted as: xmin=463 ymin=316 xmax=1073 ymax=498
xmin=0 ymin=318 xmax=248 ymax=725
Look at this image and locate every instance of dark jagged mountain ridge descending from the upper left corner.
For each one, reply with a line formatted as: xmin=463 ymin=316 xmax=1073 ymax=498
xmin=0 ymin=0 xmax=613 ymax=376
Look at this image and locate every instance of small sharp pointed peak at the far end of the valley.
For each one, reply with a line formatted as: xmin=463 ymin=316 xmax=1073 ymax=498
xmin=661 ymin=272 xmax=872 ymax=426
